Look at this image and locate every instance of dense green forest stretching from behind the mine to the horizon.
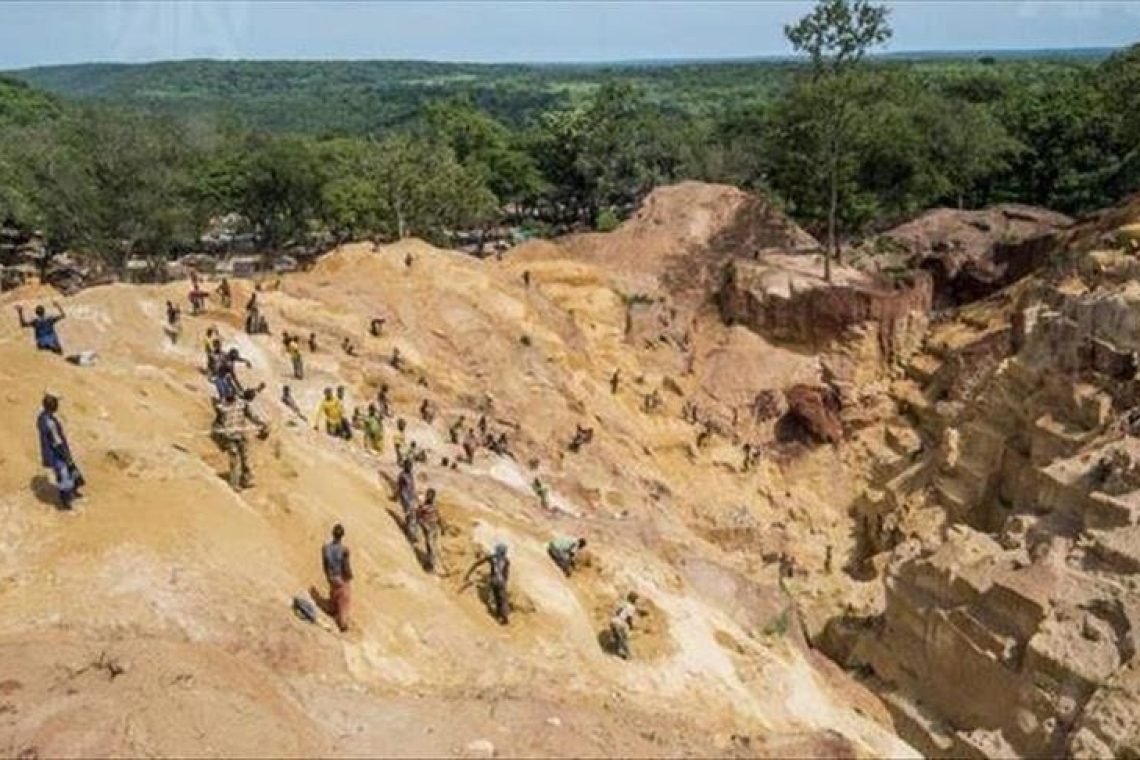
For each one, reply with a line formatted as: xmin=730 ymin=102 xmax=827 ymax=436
xmin=0 ymin=0 xmax=1140 ymax=270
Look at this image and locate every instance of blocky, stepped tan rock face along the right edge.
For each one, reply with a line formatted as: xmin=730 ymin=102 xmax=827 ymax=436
xmin=822 ymin=230 xmax=1140 ymax=757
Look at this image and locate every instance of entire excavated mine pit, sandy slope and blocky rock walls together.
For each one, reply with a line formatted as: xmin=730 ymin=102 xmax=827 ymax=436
xmin=0 ymin=183 xmax=1140 ymax=757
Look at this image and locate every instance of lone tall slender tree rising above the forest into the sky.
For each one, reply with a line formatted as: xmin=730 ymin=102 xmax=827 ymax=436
xmin=784 ymin=0 xmax=891 ymax=281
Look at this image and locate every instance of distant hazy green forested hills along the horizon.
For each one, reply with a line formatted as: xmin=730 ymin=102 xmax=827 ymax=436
xmin=9 ymin=49 xmax=1112 ymax=133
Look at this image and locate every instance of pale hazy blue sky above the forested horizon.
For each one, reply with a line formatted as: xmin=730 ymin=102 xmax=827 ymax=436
xmin=0 ymin=0 xmax=1140 ymax=68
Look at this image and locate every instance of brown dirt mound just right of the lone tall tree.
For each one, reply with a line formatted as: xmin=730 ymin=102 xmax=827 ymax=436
xmin=872 ymin=204 xmax=1073 ymax=309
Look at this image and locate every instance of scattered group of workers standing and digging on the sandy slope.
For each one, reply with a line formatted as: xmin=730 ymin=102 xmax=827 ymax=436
xmin=17 ymin=276 xmax=636 ymax=657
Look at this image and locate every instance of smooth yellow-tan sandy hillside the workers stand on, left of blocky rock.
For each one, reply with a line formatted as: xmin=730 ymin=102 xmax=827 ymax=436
xmin=0 ymin=187 xmax=911 ymax=757
